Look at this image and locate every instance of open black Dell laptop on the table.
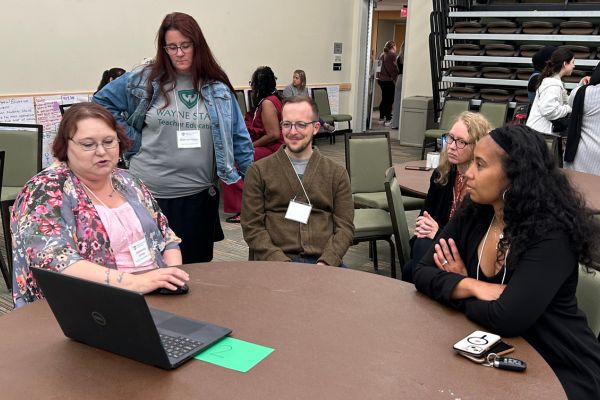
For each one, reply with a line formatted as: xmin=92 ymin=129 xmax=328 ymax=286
xmin=31 ymin=268 xmax=231 ymax=369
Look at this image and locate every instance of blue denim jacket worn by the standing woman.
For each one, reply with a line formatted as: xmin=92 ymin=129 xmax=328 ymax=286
xmin=93 ymin=68 xmax=254 ymax=184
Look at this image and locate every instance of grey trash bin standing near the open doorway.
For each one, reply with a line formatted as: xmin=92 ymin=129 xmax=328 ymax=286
xmin=400 ymin=96 xmax=435 ymax=147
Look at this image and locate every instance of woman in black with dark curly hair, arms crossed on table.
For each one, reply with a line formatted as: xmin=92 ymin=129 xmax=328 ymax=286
xmin=414 ymin=125 xmax=600 ymax=399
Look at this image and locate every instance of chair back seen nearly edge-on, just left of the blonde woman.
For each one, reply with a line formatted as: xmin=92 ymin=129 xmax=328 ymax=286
xmin=384 ymin=168 xmax=410 ymax=270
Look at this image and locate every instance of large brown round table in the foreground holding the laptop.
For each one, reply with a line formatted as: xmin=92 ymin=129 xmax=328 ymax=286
xmin=0 ymin=262 xmax=565 ymax=400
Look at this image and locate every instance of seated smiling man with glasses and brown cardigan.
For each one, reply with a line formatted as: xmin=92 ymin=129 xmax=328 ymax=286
xmin=241 ymin=96 xmax=354 ymax=266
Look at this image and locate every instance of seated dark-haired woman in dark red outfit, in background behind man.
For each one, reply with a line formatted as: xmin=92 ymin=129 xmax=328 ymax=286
xmin=221 ymin=66 xmax=283 ymax=223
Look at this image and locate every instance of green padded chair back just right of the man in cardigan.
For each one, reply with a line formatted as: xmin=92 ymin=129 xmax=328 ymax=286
xmin=344 ymin=131 xmax=392 ymax=194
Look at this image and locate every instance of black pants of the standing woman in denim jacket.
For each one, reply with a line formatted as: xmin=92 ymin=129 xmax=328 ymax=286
xmin=156 ymin=188 xmax=223 ymax=264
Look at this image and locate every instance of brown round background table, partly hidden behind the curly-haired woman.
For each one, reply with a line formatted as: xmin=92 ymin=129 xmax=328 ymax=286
xmin=394 ymin=160 xmax=600 ymax=213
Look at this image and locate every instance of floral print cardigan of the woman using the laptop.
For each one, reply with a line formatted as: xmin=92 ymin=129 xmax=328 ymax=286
xmin=10 ymin=162 xmax=181 ymax=308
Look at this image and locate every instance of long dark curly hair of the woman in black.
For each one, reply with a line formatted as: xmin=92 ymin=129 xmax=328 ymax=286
xmin=464 ymin=125 xmax=600 ymax=271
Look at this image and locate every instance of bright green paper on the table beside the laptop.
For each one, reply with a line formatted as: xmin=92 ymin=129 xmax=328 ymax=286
xmin=195 ymin=337 xmax=274 ymax=372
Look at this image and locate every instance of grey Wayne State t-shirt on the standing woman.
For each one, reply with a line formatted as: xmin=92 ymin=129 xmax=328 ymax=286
xmin=129 ymin=75 xmax=216 ymax=199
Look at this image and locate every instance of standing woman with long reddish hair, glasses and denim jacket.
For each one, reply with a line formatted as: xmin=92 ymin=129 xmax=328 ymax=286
xmin=94 ymin=12 xmax=253 ymax=264
